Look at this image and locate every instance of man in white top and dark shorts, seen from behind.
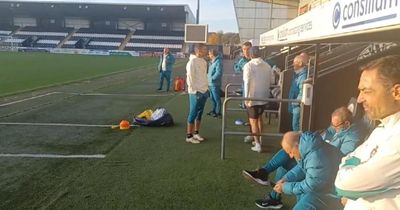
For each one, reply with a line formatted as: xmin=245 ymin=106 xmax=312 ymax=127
xmin=243 ymin=47 xmax=273 ymax=152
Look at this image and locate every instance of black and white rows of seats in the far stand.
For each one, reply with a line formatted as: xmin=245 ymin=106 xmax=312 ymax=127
xmin=0 ymin=25 xmax=184 ymax=52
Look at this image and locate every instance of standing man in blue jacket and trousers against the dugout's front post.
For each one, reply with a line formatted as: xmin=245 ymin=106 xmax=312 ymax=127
xmin=288 ymin=55 xmax=307 ymax=131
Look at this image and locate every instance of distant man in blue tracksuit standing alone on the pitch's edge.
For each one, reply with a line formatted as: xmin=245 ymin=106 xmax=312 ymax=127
xmin=157 ymin=48 xmax=175 ymax=91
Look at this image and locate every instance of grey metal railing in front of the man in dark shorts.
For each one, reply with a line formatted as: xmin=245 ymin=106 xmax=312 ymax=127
xmin=221 ymin=95 xmax=300 ymax=160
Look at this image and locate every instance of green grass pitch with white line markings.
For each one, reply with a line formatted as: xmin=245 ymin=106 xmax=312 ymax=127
xmin=0 ymin=53 xmax=295 ymax=210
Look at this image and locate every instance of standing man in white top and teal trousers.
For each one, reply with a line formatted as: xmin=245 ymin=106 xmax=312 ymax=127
xmin=186 ymin=44 xmax=208 ymax=144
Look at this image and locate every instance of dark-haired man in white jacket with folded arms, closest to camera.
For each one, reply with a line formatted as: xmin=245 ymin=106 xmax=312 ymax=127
xmin=335 ymin=55 xmax=400 ymax=210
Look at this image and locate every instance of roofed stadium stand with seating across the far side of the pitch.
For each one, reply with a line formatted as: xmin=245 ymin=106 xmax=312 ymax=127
xmin=0 ymin=0 xmax=195 ymax=53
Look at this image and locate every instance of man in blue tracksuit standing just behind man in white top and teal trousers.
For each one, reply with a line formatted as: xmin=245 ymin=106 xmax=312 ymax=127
xmin=207 ymin=49 xmax=223 ymax=117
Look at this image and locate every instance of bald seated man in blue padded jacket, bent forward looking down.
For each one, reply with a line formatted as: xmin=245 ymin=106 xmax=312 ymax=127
xmin=256 ymin=131 xmax=341 ymax=210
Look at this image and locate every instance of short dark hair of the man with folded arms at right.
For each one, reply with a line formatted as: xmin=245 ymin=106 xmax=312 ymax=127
xmin=360 ymin=55 xmax=400 ymax=85
